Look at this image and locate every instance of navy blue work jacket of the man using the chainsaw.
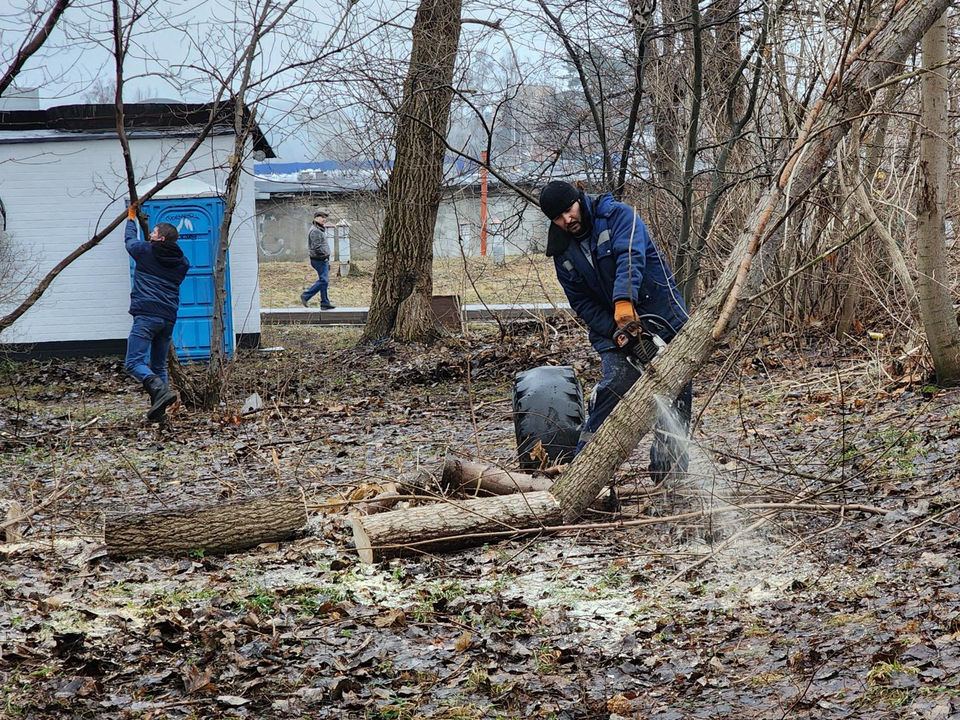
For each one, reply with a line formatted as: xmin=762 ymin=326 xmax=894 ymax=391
xmin=547 ymin=193 xmax=687 ymax=352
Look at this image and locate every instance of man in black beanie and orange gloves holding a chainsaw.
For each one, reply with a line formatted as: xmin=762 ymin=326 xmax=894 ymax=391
xmin=540 ymin=180 xmax=692 ymax=482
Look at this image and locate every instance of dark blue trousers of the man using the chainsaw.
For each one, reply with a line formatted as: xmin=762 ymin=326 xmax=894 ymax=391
xmin=574 ymin=349 xmax=693 ymax=483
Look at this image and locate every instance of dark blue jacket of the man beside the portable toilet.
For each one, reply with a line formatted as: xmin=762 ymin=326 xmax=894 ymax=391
xmin=123 ymin=220 xmax=190 ymax=322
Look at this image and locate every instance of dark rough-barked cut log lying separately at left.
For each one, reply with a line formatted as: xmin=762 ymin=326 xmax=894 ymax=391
xmin=104 ymin=492 xmax=307 ymax=557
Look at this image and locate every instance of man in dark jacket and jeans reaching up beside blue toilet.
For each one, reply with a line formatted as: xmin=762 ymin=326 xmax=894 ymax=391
xmin=123 ymin=206 xmax=190 ymax=422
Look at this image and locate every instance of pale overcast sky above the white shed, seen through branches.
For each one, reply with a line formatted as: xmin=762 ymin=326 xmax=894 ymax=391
xmin=0 ymin=0 xmax=388 ymax=161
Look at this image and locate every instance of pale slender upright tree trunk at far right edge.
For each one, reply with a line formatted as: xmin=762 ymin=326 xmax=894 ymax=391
xmin=917 ymin=13 xmax=960 ymax=385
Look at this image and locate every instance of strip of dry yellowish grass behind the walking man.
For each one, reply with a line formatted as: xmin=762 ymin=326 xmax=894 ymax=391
xmin=260 ymin=255 xmax=566 ymax=308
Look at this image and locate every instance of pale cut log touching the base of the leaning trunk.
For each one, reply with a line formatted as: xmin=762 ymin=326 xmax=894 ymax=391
xmin=349 ymin=492 xmax=562 ymax=563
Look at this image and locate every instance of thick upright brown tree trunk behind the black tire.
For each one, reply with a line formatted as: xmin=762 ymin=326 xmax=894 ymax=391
xmin=363 ymin=0 xmax=461 ymax=342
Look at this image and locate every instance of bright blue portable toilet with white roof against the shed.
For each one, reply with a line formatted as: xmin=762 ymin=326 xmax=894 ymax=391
xmin=132 ymin=180 xmax=234 ymax=362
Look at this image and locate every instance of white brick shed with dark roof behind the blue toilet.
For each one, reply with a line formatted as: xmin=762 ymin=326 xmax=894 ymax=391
xmin=0 ymin=103 xmax=273 ymax=357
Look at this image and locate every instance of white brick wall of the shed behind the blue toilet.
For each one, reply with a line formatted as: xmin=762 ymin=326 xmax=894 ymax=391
xmin=0 ymin=132 xmax=260 ymax=343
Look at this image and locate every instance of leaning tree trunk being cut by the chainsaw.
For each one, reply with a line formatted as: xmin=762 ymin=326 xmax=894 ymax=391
xmin=553 ymin=0 xmax=949 ymax=521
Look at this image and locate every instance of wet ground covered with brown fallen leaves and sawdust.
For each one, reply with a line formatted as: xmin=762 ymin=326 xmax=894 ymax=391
xmin=0 ymin=326 xmax=960 ymax=719
